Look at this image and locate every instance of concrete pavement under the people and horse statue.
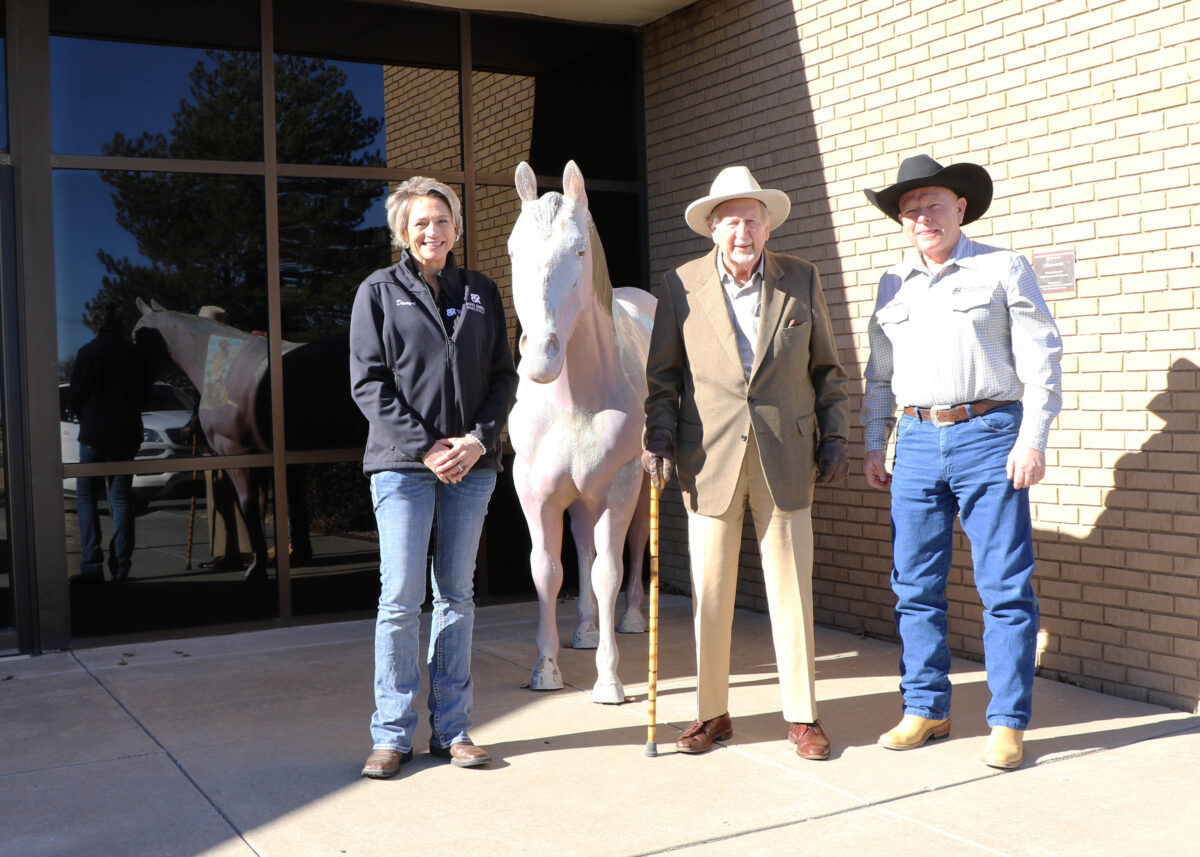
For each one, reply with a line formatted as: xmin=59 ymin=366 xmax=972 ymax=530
xmin=0 ymin=597 xmax=1200 ymax=857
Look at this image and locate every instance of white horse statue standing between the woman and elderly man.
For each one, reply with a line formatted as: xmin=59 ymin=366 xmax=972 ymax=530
xmin=509 ymin=161 xmax=656 ymax=705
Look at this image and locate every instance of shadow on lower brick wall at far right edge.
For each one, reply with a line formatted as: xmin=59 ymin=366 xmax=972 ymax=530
xmin=1034 ymin=359 xmax=1200 ymax=711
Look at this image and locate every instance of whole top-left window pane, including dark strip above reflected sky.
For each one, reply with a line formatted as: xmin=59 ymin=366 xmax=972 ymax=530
xmin=49 ymin=0 xmax=263 ymax=161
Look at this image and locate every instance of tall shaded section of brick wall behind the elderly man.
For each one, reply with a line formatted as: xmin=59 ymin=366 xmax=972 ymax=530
xmin=642 ymin=0 xmax=854 ymax=590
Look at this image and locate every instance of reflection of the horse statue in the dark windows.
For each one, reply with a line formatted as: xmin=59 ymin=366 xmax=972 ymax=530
xmin=133 ymin=298 xmax=367 ymax=581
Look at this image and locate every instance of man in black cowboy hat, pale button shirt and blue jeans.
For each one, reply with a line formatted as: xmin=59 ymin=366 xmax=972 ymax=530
xmin=863 ymin=155 xmax=1062 ymax=768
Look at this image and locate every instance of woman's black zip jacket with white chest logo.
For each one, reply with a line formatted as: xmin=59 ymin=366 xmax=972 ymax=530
xmin=350 ymin=250 xmax=517 ymax=474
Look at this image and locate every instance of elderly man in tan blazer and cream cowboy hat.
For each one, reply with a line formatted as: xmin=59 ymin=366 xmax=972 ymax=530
xmin=642 ymin=167 xmax=850 ymax=760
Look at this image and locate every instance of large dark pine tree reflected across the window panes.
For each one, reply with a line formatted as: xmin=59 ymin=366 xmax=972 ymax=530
xmin=84 ymin=50 xmax=390 ymax=341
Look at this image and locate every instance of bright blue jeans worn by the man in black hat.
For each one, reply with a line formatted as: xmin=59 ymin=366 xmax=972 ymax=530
xmin=892 ymin=403 xmax=1038 ymax=730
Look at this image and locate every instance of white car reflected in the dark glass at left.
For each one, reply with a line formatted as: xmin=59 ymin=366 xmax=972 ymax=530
xmin=59 ymin=382 xmax=204 ymax=503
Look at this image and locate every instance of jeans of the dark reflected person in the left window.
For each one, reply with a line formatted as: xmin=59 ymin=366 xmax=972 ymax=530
xmin=76 ymin=443 xmax=138 ymax=580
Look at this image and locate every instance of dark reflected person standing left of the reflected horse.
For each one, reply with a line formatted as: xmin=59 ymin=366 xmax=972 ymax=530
xmin=70 ymin=299 xmax=150 ymax=583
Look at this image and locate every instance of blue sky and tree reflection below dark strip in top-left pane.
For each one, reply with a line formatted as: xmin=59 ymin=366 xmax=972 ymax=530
xmin=50 ymin=36 xmax=263 ymax=161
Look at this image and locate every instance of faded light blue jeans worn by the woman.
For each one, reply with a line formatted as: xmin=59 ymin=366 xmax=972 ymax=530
xmin=371 ymin=468 xmax=496 ymax=753
